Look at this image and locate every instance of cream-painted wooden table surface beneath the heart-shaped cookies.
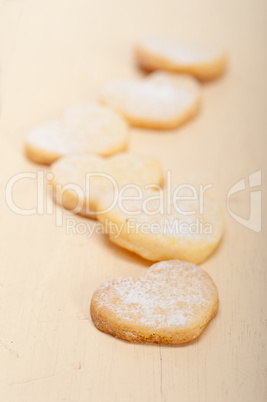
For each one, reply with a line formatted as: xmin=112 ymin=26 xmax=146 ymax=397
xmin=0 ymin=0 xmax=267 ymax=402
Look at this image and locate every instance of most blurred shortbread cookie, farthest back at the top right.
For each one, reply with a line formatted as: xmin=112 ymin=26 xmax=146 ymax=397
xmin=135 ymin=38 xmax=226 ymax=80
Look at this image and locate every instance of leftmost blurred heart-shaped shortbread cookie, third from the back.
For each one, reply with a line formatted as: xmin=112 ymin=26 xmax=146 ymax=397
xmin=25 ymin=102 xmax=128 ymax=165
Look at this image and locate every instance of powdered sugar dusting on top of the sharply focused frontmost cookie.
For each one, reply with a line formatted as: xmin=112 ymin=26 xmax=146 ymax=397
xmin=94 ymin=260 xmax=217 ymax=329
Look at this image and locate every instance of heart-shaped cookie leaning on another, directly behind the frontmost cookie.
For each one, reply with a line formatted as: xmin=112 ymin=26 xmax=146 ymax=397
xmin=97 ymin=190 xmax=223 ymax=264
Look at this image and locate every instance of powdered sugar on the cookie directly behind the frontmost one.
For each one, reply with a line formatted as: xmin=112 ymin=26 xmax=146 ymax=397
xmin=98 ymin=189 xmax=223 ymax=243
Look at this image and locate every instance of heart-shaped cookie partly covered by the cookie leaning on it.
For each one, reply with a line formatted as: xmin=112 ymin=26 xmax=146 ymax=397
xmin=51 ymin=153 xmax=163 ymax=217
